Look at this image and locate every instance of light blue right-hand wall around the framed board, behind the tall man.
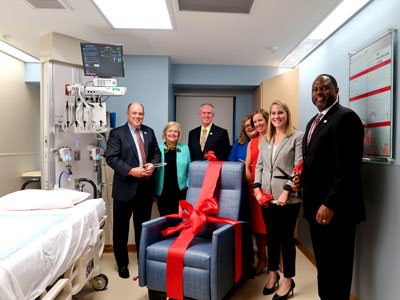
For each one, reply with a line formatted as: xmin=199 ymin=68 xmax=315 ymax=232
xmin=298 ymin=0 xmax=400 ymax=300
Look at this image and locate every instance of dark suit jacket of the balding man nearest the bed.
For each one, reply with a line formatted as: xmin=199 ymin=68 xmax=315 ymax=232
xmin=106 ymin=123 xmax=161 ymax=201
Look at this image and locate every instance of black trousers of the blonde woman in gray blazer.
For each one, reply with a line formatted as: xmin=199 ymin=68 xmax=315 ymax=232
xmin=262 ymin=203 xmax=301 ymax=278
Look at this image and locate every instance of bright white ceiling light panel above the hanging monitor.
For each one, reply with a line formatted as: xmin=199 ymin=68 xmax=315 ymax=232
xmin=92 ymin=0 xmax=172 ymax=29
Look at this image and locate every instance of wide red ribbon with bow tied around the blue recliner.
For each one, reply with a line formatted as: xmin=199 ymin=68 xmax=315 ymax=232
xmin=161 ymin=162 xmax=242 ymax=299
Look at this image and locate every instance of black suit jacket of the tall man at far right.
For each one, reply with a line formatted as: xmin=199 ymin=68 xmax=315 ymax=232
xmin=302 ymin=103 xmax=365 ymax=223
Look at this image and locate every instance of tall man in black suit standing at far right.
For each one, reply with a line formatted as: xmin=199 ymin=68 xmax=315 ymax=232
xmin=294 ymin=74 xmax=365 ymax=300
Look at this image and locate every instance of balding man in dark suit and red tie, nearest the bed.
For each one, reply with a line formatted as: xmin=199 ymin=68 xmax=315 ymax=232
xmin=106 ymin=103 xmax=161 ymax=278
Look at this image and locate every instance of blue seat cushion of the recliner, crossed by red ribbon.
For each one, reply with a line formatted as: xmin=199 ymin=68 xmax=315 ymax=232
xmin=146 ymin=237 xmax=211 ymax=270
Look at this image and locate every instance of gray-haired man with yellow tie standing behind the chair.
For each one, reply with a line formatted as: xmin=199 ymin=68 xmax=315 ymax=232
xmin=188 ymin=103 xmax=230 ymax=161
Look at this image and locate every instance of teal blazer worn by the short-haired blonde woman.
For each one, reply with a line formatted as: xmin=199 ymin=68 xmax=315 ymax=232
xmin=154 ymin=143 xmax=190 ymax=196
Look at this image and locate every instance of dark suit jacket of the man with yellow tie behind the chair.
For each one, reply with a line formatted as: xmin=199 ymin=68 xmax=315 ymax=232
xmin=188 ymin=124 xmax=231 ymax=161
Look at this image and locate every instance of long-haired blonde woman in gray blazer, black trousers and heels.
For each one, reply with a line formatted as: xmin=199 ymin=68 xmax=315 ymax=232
xmin=253 ymin=100 xmax=303 ymax=300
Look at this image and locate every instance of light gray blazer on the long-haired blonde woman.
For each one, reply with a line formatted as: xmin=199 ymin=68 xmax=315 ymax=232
xmin=254 ymin=130 xmax=304 ymax=204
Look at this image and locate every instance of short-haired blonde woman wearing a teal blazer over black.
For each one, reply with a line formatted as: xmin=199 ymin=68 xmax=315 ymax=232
xmin=154 ymin=122 xmax=190 ymax=216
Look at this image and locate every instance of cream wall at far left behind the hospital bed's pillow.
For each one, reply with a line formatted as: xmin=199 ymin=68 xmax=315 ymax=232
xmin=0 ymin=52 xmax=40 ymax=196
